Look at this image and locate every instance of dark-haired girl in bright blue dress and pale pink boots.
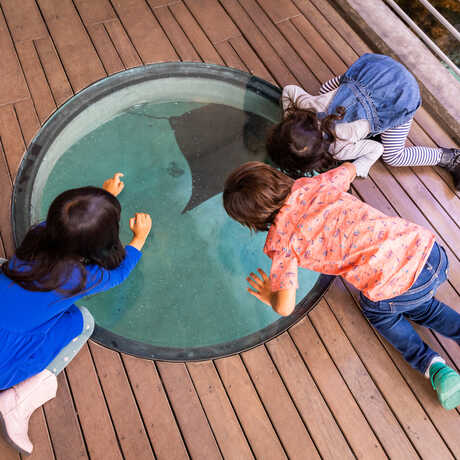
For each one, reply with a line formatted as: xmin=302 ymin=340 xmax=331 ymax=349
xmin=0 ymin=173 xmax=151 ymax=454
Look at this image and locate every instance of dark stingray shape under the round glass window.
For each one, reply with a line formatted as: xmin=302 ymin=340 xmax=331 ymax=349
xmin=169 ymin=104 xmax=273 ymax=213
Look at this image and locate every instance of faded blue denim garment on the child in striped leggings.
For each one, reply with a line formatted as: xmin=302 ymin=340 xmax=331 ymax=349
xmin=327 ymin=54 xmax=421 ymax=136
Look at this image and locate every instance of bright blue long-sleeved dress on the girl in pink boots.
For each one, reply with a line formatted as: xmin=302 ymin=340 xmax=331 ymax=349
xmin=0 ymin=246 xmax=142 ymax=390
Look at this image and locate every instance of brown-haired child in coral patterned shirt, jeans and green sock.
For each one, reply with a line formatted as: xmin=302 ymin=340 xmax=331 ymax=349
xmin=223 ymin=162 xmax=460 ymax=409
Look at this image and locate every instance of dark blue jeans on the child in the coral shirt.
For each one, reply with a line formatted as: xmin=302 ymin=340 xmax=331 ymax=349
xmin=361 ymin=243 xmax=460 ymax=374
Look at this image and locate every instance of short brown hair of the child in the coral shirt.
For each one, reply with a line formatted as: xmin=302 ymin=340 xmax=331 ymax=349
xmin=223 ymin=161 xmax=294 ymax=231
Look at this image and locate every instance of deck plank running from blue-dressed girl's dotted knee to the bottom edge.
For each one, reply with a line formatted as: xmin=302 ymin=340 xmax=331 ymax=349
xmin=66 ymin=345 xmax=122 ymax=460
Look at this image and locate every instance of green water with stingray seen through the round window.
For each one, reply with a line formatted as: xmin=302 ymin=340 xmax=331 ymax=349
xmin=40 ymin=102 xmax=318 ymax=347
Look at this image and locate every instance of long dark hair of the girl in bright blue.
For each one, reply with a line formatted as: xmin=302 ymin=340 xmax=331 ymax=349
xmin=2 ymin=187 xmax=125 ymax=295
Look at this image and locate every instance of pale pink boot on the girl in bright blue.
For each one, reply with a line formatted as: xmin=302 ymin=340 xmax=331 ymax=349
xmin=0 ymin=369 xmax=57 ymax=454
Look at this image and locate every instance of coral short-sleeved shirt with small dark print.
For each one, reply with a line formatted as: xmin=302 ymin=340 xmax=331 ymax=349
xmin=264 ymin=165 xmax=435 ymax=301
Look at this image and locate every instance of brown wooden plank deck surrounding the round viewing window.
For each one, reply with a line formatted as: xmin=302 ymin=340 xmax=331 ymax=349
xmin=0 ymin=0 xmax=460 ymax=460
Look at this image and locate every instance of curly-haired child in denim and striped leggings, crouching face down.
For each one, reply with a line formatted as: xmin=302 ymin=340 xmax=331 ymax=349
xmin=267 ymin=54 xmax=460 ymax=185
